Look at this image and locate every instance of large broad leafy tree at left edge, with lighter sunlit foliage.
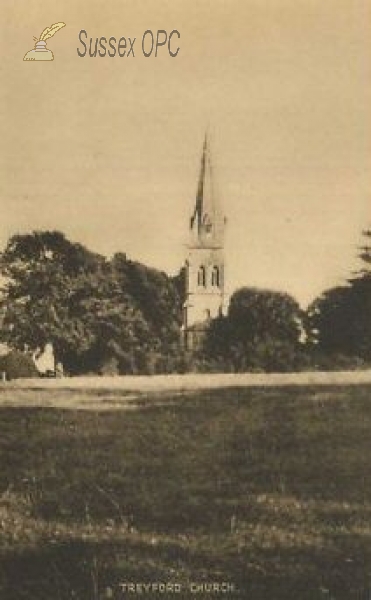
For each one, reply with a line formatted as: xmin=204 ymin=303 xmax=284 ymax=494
xmin=1 ymin=231 xmax=150 ymax=372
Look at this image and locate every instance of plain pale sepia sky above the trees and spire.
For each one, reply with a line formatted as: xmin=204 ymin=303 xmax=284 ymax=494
xmin=0 ymin=0 xmax=371 ymax=305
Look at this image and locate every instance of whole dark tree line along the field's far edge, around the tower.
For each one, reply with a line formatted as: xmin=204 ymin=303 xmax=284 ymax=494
xmin=0 ymin=231 xmax=371 ymax=375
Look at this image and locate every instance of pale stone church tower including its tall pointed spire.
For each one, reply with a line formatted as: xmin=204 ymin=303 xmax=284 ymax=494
xmin=183 ymin=136 xmax=226 ymax=350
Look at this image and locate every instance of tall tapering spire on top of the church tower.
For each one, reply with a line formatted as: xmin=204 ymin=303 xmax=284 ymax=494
xmin=190 ymin=132 xmax=224 ymax=246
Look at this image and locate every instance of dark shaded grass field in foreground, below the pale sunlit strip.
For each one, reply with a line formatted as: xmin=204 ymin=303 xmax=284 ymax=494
xmin=0 ymin=385 xmax=371 ymax=600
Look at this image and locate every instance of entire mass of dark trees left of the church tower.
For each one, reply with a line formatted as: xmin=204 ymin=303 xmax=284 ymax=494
xmin=0 ymin=231 xmax=185 ymax=373
